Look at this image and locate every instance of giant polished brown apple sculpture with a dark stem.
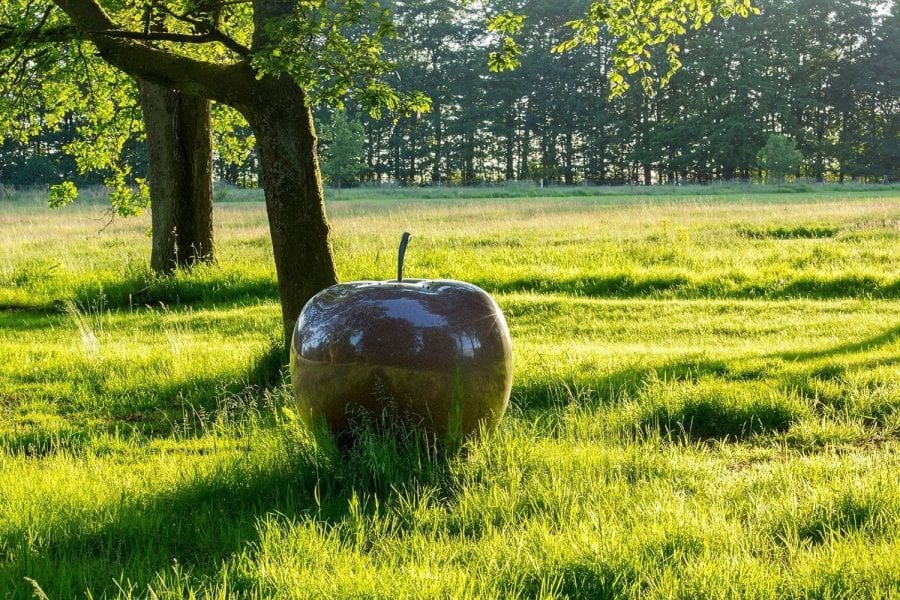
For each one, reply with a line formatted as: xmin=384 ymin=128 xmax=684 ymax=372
xmin=291 ymin=233 xmax=512 ymax=446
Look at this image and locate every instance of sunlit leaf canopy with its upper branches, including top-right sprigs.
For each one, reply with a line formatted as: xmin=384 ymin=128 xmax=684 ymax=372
xmin=0 ymin=0 xmax=756 ymax=195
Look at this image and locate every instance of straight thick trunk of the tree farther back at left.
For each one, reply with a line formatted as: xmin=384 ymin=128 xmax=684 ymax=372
xmin=141 ymin=81 xmax=213 ymax=274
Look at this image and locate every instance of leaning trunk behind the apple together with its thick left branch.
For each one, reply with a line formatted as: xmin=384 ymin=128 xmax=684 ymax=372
xmin=53 ymin=0 xmax=337 ymax=343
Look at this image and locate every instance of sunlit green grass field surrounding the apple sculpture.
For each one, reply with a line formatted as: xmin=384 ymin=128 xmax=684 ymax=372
xmin=0 ymin=189 xmax=900 ymax=599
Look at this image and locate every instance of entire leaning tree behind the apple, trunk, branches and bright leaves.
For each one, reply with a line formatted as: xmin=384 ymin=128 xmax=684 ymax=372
xmin=0 ymin=0 xmax=749 ymax=339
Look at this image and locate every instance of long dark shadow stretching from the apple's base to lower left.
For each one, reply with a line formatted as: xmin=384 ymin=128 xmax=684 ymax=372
xmin=0 ymin=426 xmax=448 ymax=599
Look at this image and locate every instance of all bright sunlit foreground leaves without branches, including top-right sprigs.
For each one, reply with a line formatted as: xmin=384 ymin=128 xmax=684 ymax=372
xmin=0 ymin=0 xmax=752 ymax=199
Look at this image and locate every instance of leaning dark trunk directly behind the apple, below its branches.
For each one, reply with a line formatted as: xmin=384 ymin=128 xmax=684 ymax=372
xmin=241 ymin=77 xmax=337 ymax=344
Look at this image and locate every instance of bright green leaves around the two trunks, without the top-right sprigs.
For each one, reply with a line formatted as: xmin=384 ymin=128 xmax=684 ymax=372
xmin=0 ymin=0 xmax=429 ymax=209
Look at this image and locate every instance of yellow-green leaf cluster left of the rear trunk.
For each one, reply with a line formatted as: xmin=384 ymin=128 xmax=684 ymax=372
xmin=0 ymin=0 xmax=147 ymax=215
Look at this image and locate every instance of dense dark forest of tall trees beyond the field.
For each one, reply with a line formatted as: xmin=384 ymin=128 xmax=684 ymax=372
xmin=0 ymin=0 xmax=900 ymax=186
